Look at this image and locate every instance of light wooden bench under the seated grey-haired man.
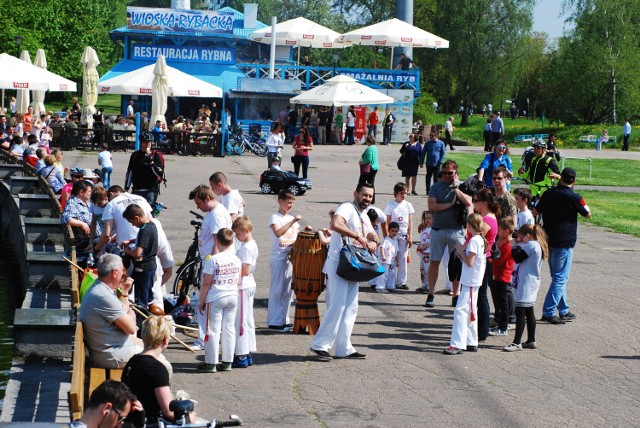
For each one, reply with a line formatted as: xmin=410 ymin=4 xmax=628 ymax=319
xmin=69 ymin=321 xmax=122 ymax=420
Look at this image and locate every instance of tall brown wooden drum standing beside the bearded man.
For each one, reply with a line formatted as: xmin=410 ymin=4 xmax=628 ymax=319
xmin=290 ymin=232 xmax=327 ymax=335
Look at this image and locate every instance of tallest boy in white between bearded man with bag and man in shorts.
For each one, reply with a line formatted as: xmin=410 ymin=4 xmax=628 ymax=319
xmin=384 ymin=183 xmax=415 ymax=290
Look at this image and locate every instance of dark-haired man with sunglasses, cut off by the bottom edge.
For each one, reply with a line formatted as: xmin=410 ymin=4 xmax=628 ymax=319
xmin=71 ymin=380 xmax=142 ymax=428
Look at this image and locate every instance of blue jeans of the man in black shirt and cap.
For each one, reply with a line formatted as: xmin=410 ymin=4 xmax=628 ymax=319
xmin=542 ymin=248 xmax=573 ymax=316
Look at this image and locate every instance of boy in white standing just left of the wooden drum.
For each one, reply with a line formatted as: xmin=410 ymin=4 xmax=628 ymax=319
xmin=267 ymin=189 xmax=302 ymax=332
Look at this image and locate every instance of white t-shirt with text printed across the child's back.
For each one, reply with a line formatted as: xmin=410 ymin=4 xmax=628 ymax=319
xmin=202 ymin=248 xmax=242 ymax=303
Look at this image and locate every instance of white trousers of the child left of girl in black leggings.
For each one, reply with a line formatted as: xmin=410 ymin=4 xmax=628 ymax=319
xmin=449 ymin=284 xmax=478 ymax=349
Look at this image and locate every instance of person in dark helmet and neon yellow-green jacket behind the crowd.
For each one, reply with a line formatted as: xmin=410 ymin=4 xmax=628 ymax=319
xmin=518 ymin=140 xmax=560 ymax=197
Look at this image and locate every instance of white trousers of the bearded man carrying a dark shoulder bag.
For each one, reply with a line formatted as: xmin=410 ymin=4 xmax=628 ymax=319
xmin=311 ymin=259 xmax=358 ymax=357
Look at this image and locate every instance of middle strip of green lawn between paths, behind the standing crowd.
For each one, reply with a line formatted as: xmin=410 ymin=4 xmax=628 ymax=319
xmin=447 ymin=152 xmax=640 ymax=187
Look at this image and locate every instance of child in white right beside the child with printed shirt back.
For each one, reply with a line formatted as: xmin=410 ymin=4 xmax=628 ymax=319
xmin=232 ymin=216 xmax=259 ymax=368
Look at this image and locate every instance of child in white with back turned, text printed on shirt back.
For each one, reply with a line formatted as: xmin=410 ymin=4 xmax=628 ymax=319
xmin=197 ymin=228 xmax=242 ymax=373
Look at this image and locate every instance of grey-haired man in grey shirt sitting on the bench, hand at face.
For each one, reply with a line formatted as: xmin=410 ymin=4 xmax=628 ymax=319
xmin=79 ymin=254 xmax=142 ymax=369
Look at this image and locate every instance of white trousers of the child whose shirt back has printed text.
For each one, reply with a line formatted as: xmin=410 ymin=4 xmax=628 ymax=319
xmin=204 ymin=295 xmax=238 ymax=364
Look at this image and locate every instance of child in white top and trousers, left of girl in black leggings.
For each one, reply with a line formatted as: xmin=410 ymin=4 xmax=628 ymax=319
xmin=444 ymin=214 xmax=487 ymax=355
